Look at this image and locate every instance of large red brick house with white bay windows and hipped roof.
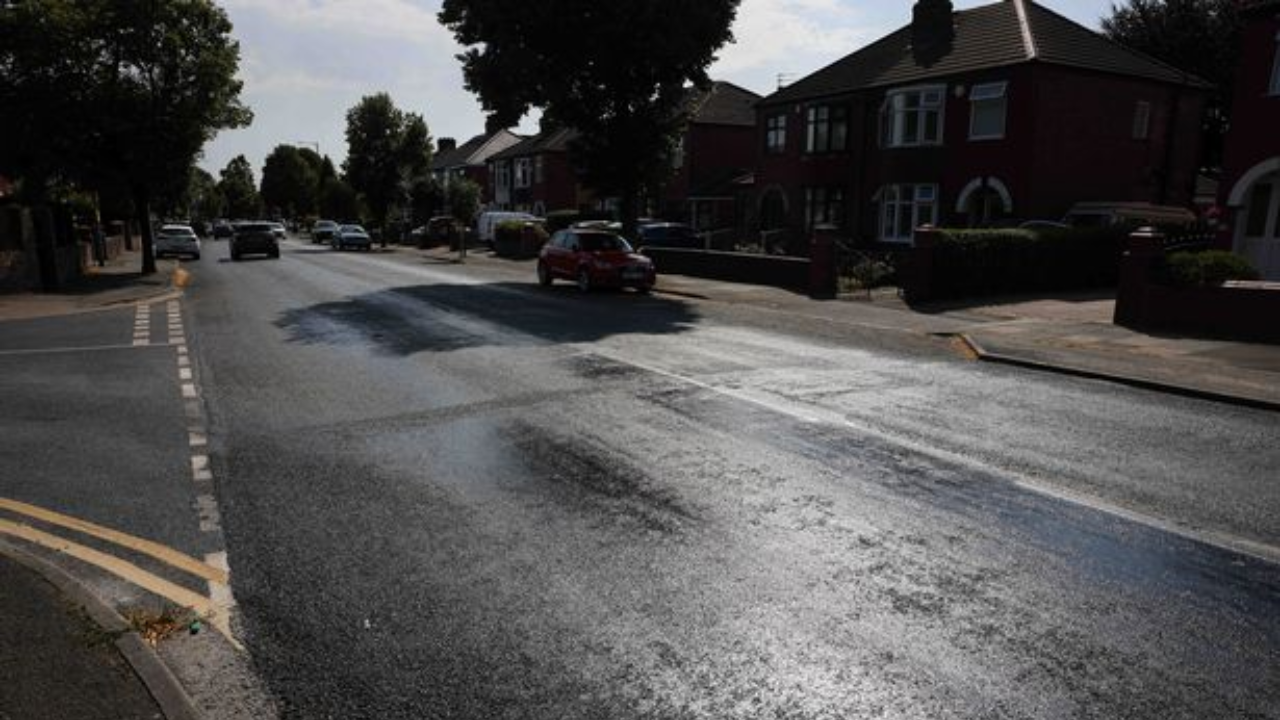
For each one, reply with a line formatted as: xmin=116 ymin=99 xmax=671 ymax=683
xmin=750 ymin=0 xmax=1206 ymax=252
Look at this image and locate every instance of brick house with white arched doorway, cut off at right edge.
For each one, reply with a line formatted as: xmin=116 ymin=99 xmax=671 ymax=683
xmin=1221 ymin=0 xmax=1280 ymax=281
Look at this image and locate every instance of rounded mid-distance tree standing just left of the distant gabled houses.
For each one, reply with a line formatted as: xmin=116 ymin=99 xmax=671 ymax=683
xmin=343 ymin=92 xmax=431 ymax=227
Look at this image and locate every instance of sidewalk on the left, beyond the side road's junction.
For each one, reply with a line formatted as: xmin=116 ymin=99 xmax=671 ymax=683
xmin=0 ymin=250 xmax=178 ymax=320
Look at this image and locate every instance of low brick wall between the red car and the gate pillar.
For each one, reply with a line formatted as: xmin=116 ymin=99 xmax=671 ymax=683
xmin=643 ymin=247 xmax=810 ymax=292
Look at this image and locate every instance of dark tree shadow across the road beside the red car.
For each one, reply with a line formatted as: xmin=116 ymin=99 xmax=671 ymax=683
xmin=275 ymin=282 xmax=699 ymax=355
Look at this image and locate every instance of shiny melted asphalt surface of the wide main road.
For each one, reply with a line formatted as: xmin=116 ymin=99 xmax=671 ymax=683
xmin=188 ymin=243 xmax=1280 ymax=719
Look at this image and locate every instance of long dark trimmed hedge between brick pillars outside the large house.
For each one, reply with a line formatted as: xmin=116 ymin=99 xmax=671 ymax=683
xmin=931 ymin=228 xmax=1126 ymax=299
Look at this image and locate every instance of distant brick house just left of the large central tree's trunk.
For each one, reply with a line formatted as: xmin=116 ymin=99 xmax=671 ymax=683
xmin=486 ymin=129 xmax=591 ymax=217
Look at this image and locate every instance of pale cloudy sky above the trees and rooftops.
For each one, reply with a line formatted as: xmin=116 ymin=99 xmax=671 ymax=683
xmin=200 ymin=0 xmax=1112 ymax=179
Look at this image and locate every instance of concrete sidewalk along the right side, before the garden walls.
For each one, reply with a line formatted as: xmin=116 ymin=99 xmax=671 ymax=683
xmin=402 ymin=243 xmax=1280 ymax=410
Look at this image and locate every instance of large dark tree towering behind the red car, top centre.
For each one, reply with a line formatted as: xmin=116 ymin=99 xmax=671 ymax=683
xmin=439 ymin=0 xmax=739 ymax=225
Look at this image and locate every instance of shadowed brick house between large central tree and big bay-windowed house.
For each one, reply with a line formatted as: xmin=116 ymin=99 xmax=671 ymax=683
xmin=659 ymin=81 xmax=760 ymax=229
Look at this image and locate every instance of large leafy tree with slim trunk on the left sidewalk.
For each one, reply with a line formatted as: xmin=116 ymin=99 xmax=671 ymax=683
xmin=0 ymin=0 xmax=252 ymax=273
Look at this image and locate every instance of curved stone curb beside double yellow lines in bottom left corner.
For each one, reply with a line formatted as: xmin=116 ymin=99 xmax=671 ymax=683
xmin=0 ymin=539 xmax=201 ymax=720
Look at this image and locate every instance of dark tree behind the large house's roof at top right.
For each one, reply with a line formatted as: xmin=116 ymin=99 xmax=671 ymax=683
xmin=1102 ymin=0 xmax=1242 ymax=167
